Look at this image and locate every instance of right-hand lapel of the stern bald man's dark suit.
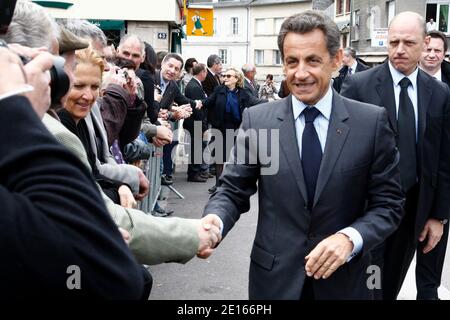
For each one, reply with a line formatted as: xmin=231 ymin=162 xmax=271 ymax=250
xmin=417 ymin=69 xmax=432 ymax=163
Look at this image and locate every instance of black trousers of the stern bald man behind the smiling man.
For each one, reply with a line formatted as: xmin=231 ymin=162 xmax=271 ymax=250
xmin=372 ymin=185 xmax=419 ymax=300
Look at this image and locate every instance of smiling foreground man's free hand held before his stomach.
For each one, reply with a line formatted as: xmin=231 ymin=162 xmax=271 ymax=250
xmin=305 ymin=233 xmax=353 ymax=280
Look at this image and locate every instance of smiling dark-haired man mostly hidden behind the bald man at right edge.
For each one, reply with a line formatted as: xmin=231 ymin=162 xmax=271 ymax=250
xmin=416 ymin=30 xmax=450 ymax=300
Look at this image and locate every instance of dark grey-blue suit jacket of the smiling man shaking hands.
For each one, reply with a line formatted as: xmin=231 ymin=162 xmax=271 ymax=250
xmin=204 ymin=92 xmax=403 ymax=300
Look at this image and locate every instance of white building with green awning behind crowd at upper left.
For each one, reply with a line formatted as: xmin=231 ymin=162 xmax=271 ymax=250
xmin=33 ymin=0 xmax=183 ymax=52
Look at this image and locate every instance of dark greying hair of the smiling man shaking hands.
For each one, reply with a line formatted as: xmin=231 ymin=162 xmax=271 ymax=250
xmin=278 ymin=10 xmax=341 ymax=59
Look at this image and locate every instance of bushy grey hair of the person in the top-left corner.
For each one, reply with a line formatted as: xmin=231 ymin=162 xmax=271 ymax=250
xmin=2 ymin=0 xmax=59 ymax=50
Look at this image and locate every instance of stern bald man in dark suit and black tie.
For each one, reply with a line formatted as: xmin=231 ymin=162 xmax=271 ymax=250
xmin=341 ymin=12 xmax=450 ymax=300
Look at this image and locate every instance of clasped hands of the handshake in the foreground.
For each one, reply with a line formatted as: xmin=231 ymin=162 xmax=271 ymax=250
xmin=197 ymin=214 xmax=222 ymax=259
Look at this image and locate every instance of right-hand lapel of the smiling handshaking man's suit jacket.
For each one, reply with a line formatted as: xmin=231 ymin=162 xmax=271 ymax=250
xmin=313 ymin=90 xmax=350 ymax=206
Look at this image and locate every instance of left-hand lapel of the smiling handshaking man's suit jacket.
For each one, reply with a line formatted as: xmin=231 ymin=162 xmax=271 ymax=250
xmin=277 ymin=95 xmax=308 ymax=201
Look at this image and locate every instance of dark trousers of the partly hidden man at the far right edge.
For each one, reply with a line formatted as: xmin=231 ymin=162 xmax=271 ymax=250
xmin=416 ymin=223 xmax=449 ymax=300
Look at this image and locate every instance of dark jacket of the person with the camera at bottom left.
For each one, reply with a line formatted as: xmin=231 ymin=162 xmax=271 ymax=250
xmin=0 ymin=96 xmax=143 ymax=299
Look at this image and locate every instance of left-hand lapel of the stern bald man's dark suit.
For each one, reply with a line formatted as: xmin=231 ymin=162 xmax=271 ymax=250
xmin=375 ymin=62 xmax=397 ymax=133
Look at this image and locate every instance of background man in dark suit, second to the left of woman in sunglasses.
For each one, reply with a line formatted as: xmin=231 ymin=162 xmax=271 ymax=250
xmin=183 ymin=63 xmax=208 ymax=182
